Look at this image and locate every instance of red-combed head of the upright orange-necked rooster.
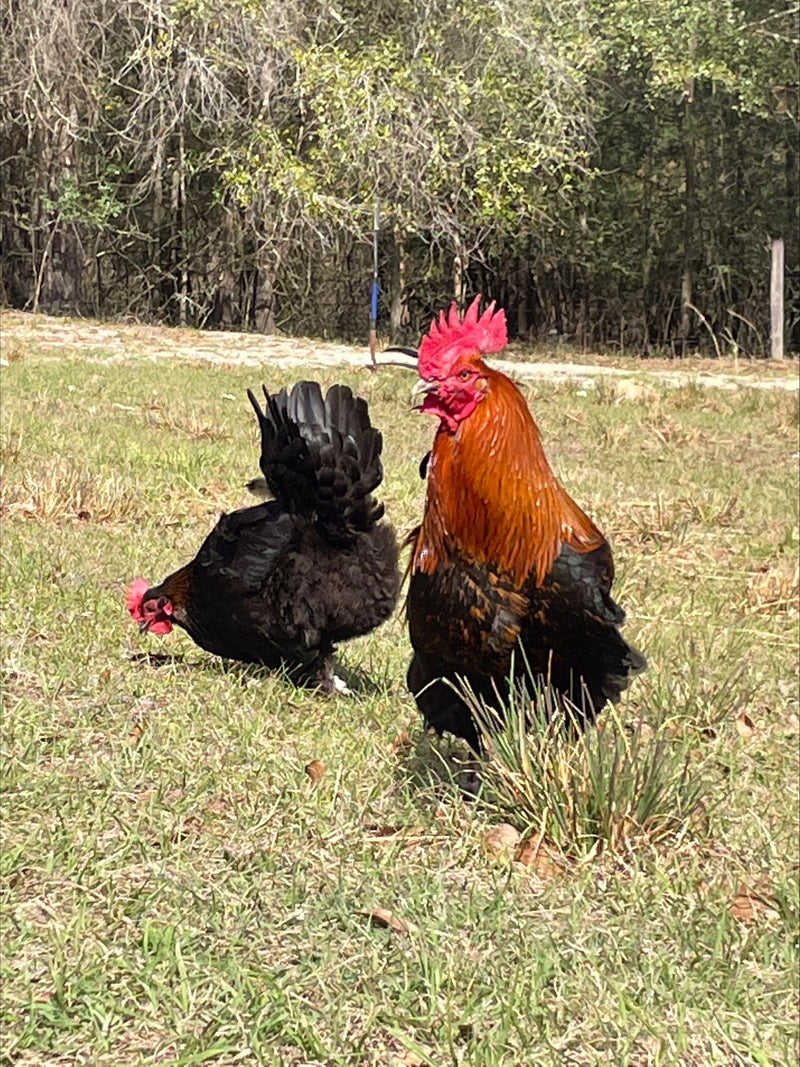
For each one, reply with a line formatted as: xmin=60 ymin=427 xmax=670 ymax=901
xmin=417 ymin=293 xmax=509 ymax=433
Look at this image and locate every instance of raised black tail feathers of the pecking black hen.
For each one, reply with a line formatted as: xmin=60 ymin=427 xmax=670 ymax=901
xmin=247 ymin=381 xmax=384 ymax=541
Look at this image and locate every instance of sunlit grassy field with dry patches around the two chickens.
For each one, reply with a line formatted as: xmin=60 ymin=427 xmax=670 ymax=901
xmin=0 ymin=326 xmax=798 ymax=1067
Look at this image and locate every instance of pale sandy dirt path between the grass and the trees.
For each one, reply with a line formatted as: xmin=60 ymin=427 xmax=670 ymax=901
xmin=0 ymin=312 xmax=800 ymax=391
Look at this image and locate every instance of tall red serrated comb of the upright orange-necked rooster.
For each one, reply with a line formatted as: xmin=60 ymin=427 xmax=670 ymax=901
xmin=417 ymin=293 xmax=509 ymax=378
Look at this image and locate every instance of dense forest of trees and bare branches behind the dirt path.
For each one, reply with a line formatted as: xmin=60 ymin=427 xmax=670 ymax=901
xmin=0 ymin=0 xmax=800 ymax=355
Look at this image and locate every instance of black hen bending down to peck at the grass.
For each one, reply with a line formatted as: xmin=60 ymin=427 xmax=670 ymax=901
xmin=127 ymin=382 xmax=400 ymax=691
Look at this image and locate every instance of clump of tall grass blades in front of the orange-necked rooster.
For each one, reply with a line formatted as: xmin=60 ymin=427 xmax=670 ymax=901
xmin=457 ymin=680 xmax=710 ymax=859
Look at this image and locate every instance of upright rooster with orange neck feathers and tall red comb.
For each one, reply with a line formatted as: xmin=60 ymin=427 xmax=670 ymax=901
xmin=406 ymin=296 xmax=645 ymax=752
